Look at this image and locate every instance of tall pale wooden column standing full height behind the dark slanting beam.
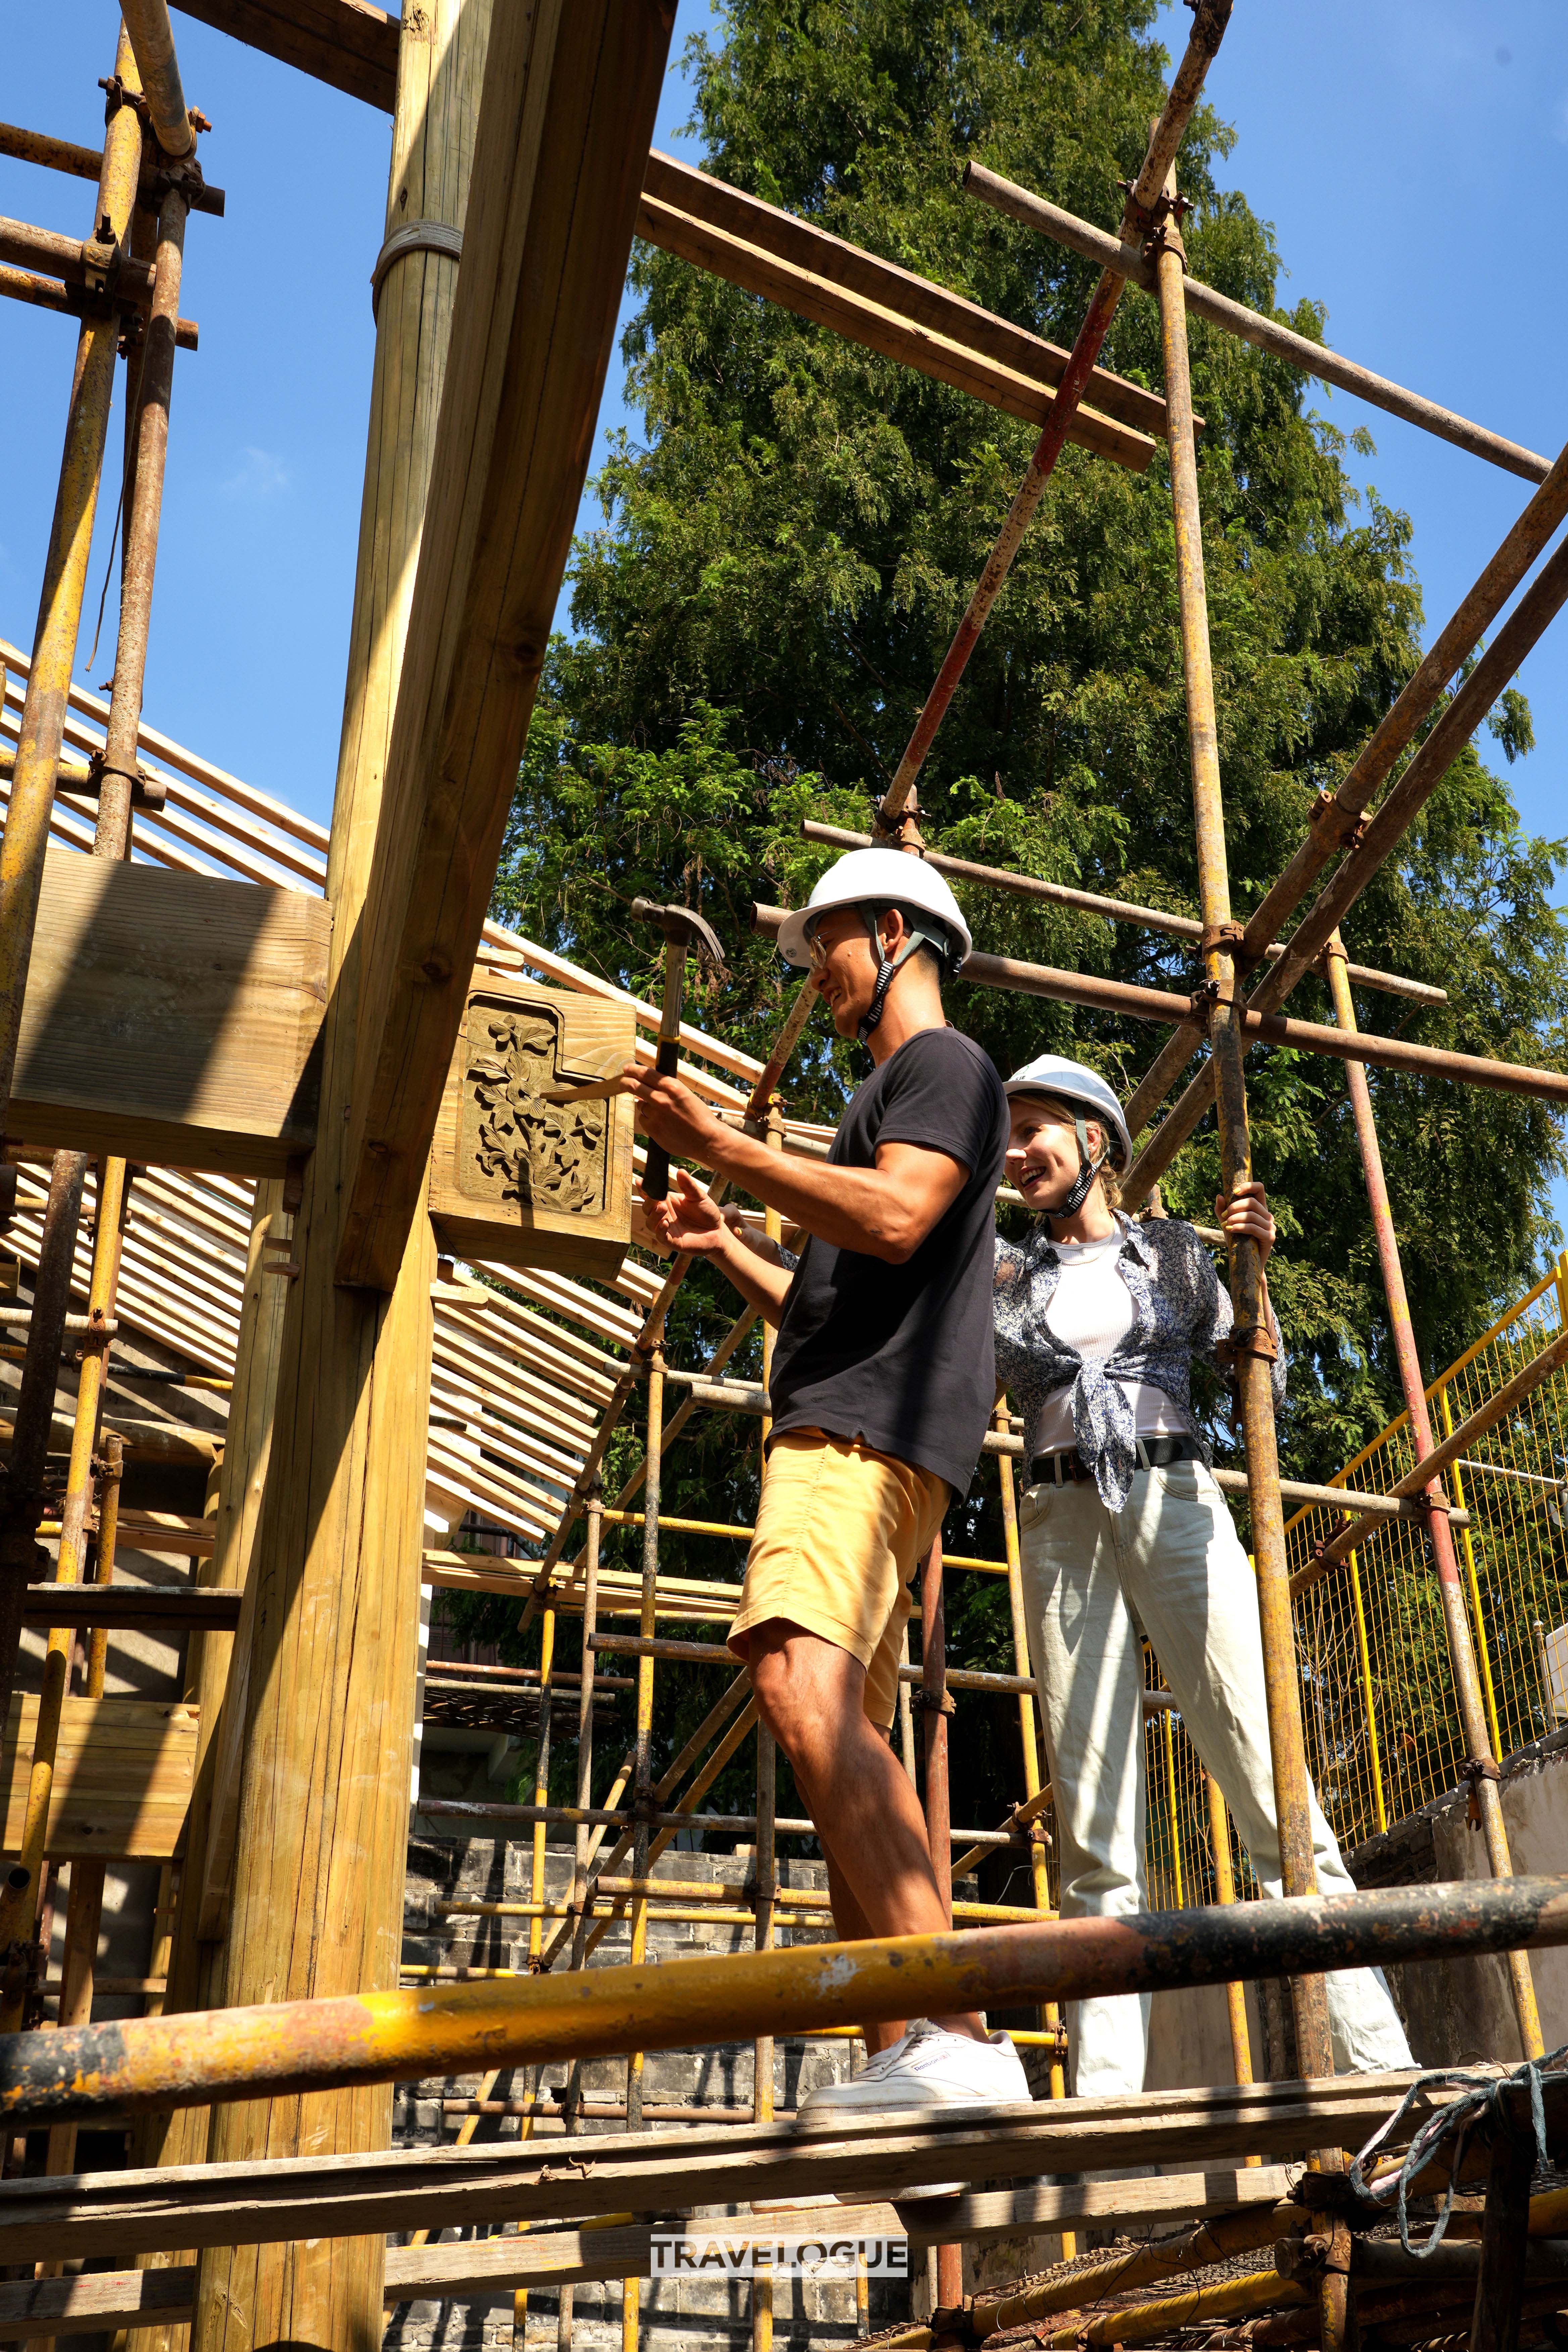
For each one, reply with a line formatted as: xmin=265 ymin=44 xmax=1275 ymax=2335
xmin=193 ymin=0 xmax=489 ymax=2352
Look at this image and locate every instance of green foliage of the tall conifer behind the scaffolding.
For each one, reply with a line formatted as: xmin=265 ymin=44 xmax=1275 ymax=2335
xmin=479 ymin=0 xmax=1568 ymax=1834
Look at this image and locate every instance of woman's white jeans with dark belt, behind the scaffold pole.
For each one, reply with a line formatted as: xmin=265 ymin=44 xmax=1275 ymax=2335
xmin=1018 ymin=1463 xmax=1415 ymax=2098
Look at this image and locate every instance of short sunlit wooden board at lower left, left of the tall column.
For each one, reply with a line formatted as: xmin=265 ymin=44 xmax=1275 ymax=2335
xmin=0 ymin=1703 xmax=197 ymax=1863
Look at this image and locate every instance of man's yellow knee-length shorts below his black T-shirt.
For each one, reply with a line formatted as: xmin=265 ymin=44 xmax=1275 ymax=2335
xmin=729 ymin=1430 xmax=950 ymax=1731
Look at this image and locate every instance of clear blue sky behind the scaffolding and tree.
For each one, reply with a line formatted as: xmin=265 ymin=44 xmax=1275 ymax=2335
xmin=0 ymin=0 xmax=1568 ymax=1223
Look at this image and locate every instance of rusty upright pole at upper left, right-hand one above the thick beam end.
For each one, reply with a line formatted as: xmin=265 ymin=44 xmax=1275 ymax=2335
xmin=94 ymin=172 xmax=190 ymax=856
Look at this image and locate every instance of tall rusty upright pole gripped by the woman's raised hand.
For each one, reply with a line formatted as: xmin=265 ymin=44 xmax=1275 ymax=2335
xmin=1157 ymin=184 xmax=1333 ymax=2074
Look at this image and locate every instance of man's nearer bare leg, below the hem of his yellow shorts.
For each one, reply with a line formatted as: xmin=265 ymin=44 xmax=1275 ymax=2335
xmin=747 ymin=1618 xmax=987 ymax=2046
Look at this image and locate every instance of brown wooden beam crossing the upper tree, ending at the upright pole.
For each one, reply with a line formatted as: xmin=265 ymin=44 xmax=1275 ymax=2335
xmin=637 ymin=151 xmax=1166 ymax=473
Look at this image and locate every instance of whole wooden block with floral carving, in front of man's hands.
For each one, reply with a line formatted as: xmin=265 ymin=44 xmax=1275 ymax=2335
xmin=430 ymin=978 xmax=635 ymax=1277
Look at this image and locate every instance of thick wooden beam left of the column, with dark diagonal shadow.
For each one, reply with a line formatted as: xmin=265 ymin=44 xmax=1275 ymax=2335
xmin=9 ymin=849 xmax=332 ymax=1176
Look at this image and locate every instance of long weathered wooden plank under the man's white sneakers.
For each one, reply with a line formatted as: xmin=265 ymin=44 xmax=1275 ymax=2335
xmin=0 ymin=2072 xmax=1448 ymax=2265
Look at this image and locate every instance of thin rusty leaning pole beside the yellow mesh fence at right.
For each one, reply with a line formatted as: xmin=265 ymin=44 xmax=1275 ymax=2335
xmin=1328 ymin=931 xmax=1545 ymax=2058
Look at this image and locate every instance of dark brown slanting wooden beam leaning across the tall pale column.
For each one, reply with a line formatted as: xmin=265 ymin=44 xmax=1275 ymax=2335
xmin=339 ymin=0 xmax=675 ymax=1289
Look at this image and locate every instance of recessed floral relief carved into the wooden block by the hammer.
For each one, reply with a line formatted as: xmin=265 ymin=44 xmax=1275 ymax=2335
xmin=458 ymin=997 xmax=609 ymax=1216
